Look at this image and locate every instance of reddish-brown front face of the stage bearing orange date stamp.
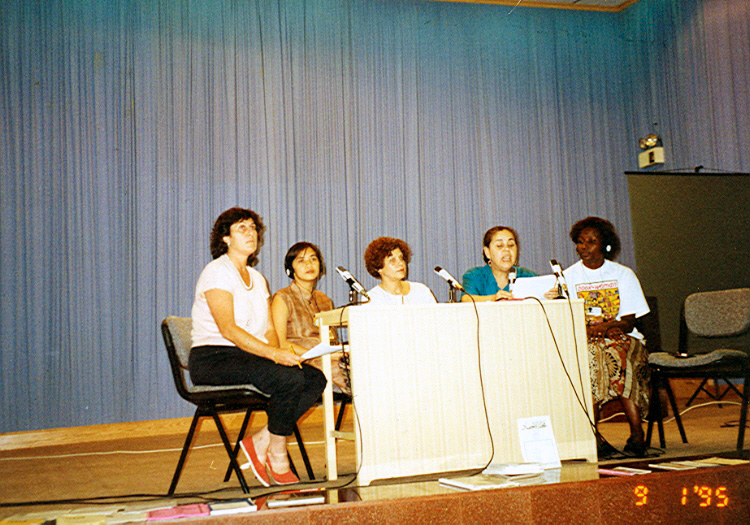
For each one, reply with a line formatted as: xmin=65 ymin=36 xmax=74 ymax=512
xmin=241 ymin=465 xmax=750 ymax=525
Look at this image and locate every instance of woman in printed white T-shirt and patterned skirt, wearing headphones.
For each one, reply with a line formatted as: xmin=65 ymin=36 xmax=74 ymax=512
xmin=551 ymin=217 xmax=649 ymax=457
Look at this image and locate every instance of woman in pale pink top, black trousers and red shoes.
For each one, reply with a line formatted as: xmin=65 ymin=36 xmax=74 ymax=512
xmin=189 ymin=208 xmax=326 ymax=487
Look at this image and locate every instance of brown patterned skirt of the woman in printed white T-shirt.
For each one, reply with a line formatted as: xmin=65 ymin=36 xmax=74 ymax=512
xmin=588 ymin=336 xmax=651 ymax=417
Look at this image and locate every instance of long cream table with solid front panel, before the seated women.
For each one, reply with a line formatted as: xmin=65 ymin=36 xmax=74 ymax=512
xmin=316 ymin=299 xmax=597 ymax=485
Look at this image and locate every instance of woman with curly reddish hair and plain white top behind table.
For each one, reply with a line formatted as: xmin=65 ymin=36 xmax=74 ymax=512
xmin=365 ymin=237 xmax=437 ymax=304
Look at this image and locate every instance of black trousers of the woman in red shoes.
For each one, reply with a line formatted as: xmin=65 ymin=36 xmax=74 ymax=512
xmin=188 ymin=346 xmax=326 ymax=436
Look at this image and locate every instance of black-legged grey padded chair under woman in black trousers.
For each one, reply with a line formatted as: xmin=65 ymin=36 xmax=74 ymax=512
xmin=161 ymin=316 xmax=315 ymax=496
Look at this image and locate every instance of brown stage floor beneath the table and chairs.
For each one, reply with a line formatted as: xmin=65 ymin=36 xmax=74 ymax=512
xmin=0 ymin=382 xmax=750 ymax=522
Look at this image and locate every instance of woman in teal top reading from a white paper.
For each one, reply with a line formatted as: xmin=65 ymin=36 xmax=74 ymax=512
xmin=461 ymin=226 xmax=536 ymax=301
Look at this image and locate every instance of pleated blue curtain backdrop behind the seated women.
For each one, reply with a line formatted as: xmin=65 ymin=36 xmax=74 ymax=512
xmin=0 ymin=0 xmax=750 ymax=432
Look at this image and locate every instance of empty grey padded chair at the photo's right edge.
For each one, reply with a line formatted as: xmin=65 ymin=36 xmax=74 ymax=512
xmin=646 ymin=288 xmax=750 ymax=452
